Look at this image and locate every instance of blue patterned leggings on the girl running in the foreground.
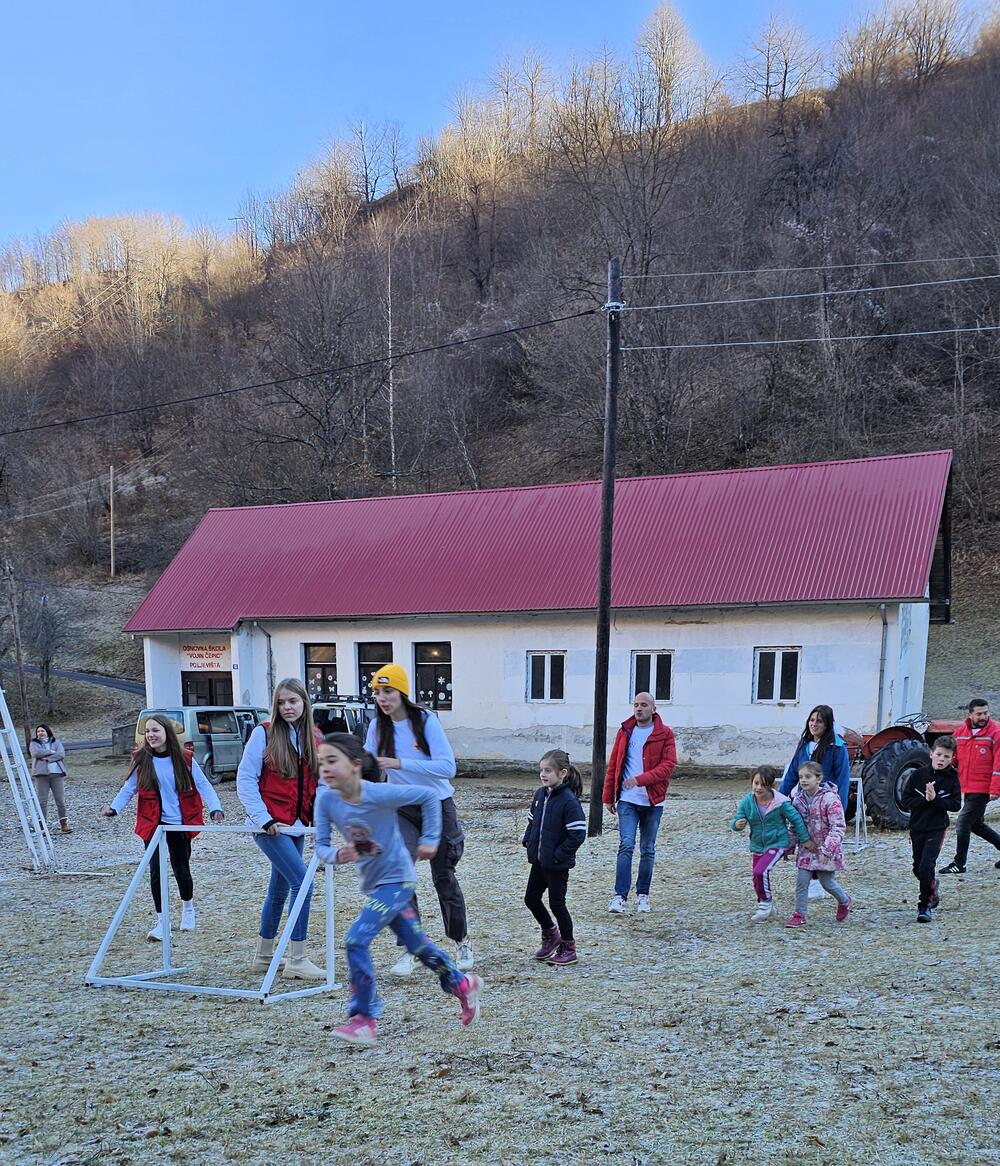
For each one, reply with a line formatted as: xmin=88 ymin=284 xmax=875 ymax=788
xmin=344 ymin=883 xmax=465 ymax=1017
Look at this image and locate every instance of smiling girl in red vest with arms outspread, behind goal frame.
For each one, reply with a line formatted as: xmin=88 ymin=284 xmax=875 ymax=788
xmin=100 ymin=712 xmax=225 ymax=940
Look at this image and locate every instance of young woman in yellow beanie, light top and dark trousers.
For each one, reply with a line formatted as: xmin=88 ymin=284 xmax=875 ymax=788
xmin=365 ymin=663 xmax=474 ymax=976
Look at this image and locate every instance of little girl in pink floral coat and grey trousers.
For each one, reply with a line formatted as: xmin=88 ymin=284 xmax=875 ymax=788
xmin=784 ymin=761 xmax=851 ymax=927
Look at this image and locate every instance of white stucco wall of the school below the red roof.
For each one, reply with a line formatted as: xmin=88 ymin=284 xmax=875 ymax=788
xmin=138 ymin=604 xmax=928 ymax=765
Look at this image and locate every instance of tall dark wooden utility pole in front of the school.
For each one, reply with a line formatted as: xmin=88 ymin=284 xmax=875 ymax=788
xmin=587 ymin=258 xmax=625 ymax=837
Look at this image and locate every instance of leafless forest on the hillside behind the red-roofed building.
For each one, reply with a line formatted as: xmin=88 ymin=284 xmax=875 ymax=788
xmin=0 ymin=0 xmax=1000 ymax=587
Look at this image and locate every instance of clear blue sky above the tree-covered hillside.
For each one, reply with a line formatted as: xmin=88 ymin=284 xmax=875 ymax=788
xmin=0 ymin=0 xmax=859 ymax=244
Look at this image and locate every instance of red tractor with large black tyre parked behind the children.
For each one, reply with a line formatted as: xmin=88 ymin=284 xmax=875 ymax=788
xmin=840 ymin=712 xmax=962 ymax=830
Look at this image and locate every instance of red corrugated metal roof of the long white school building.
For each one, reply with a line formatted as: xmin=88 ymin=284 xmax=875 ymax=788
xmin=125 ymin=450 xmax=951 ymax=632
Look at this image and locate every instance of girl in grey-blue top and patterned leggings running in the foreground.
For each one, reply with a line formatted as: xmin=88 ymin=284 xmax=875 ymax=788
xmin=316 ymin=732 xmax=483 ymax=1045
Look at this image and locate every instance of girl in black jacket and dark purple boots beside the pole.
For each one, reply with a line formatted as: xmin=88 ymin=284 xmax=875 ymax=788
xmin=521 ymin=749 xmax=586 ymax=967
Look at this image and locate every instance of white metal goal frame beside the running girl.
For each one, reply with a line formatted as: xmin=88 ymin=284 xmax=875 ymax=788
xmin=84 ymin=824 xmax=340 ymax=1004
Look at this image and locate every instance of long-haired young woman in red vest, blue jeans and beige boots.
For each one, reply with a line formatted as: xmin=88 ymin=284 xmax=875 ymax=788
xmin=237 ymin=677 xmax=326 ymax=979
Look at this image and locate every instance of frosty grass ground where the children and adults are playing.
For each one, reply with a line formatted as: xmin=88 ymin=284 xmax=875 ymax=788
xmin=0 ymin=754 xmax=1000 ymax=1166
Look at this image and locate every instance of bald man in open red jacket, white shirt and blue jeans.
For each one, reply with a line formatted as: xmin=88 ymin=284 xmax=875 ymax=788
xmin=603 ymin=693 xmax=677 ymax=915
